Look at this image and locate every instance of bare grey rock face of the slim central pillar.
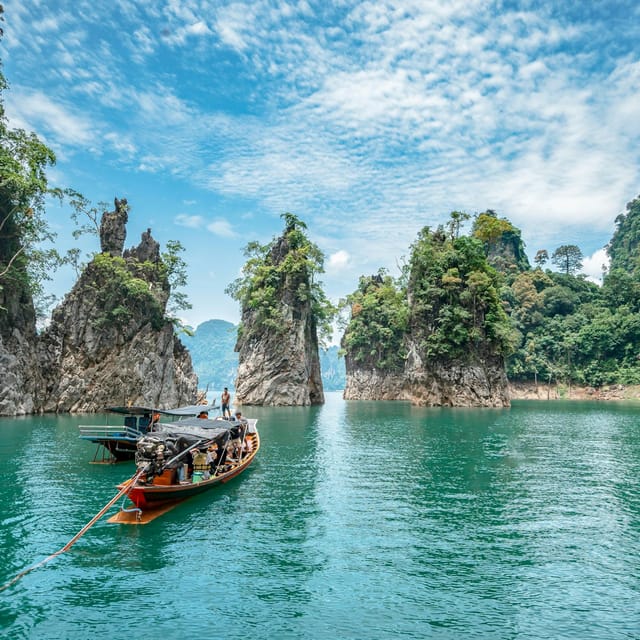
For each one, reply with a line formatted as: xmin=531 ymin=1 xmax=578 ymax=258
xmin=235 ymin=228 xmax=324 ymax=406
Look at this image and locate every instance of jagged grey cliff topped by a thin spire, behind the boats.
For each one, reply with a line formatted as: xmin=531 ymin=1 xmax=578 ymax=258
xmin=39 ymin=201 xmax=197 ymax=412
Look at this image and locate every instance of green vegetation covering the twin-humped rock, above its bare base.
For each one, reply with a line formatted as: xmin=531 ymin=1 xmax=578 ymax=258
xmin=342 ymin=218 xmax=519 ymax=372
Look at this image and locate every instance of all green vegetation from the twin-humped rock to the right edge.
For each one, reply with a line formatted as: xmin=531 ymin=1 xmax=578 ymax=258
xmin=342 ymin=198 xmax=640 ymax=387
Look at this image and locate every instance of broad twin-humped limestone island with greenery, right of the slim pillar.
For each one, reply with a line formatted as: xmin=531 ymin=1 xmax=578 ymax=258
xmin=342 ymin=228 xmax=510 ymax=407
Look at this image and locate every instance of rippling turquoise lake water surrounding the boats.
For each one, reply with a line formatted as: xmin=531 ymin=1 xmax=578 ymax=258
xmin=0 ymin=393 xmax=640 ymax=640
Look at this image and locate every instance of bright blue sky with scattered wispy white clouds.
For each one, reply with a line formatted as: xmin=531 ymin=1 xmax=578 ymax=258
xmin=0 ymin=0 xmax=640 ymax=336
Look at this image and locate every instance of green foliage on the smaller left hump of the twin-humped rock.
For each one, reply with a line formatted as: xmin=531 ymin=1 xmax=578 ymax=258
xmin=340 ymin=269 xmax=409 ymax=371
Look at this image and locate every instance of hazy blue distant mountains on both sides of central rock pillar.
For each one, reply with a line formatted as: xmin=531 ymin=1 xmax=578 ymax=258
xmin=180 ymin=320 xmax=345 ymax=391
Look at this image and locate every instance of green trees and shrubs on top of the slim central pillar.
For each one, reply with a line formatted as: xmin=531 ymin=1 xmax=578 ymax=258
xmin=225 ymin=213 xmax=335 ymax=339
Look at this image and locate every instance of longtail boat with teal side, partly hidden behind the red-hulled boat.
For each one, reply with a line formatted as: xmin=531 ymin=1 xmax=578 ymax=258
xmin=78 ymin=401 xmax=218 ymax=463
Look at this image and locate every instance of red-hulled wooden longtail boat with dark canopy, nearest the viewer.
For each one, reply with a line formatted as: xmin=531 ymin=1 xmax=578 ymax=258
xmin=109 ymin=418 xmax=260 ymax=524
